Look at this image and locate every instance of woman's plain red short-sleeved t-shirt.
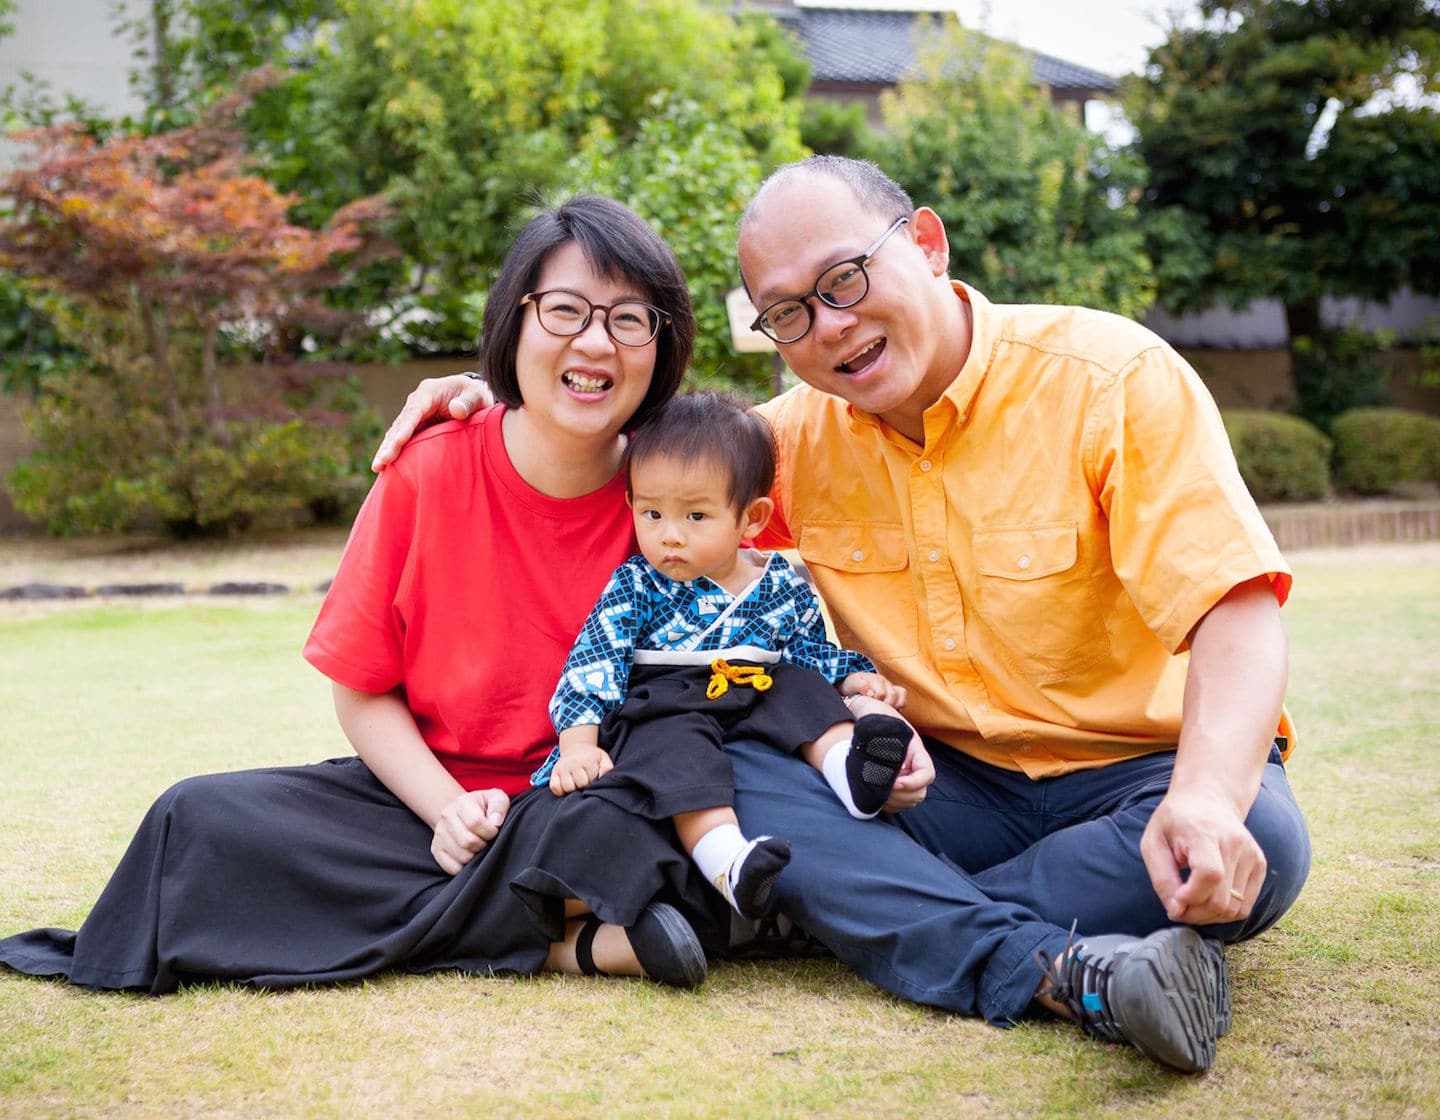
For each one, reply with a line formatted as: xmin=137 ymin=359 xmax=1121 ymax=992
xmin=305 ymin=405 xmax=638 ymax=793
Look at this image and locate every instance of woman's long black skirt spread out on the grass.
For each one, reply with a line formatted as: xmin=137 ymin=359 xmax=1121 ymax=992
xmin=0 ymin=759 xmax=729 ymax=995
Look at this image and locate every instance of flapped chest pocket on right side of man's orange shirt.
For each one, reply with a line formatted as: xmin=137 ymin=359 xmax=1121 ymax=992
xmin=972 ymin=521 xmax=1110 ymax=684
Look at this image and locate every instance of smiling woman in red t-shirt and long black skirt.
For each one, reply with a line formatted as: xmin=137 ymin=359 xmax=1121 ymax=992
xmin=0 ymin=196 xmax=729 ymax=993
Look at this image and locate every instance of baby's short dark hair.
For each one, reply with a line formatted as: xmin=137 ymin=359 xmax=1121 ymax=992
xmin=625 ymin=392 xmax=775 ymax=514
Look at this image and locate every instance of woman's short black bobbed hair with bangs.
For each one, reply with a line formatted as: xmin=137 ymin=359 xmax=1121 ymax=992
xmin=480 ymin=194 xmax=696 ymax=428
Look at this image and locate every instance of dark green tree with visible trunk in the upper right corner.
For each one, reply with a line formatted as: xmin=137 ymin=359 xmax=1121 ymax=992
xmin=1126 ymin=0 xmax=1440 ymax=419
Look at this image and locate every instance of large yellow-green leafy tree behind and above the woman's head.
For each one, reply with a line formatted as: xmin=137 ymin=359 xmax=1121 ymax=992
xmin=249 ymin=0 xmax=801 ymax=353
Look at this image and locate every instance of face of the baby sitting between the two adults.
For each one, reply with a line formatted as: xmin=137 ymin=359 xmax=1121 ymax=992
xmin=631 ymin=455 xmax=755 ymax=582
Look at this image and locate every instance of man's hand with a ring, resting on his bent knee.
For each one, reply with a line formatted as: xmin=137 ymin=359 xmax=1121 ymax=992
xmin=1140 ymin=787 xmax=1266 ymax=926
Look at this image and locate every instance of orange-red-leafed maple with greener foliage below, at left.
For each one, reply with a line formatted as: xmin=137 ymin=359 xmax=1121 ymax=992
xmin=0 ymin=95 xmax=384 ymax=531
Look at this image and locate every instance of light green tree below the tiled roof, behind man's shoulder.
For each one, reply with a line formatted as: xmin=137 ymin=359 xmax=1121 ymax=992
xmin=874 ymin=22 xmax=1155 ymax=317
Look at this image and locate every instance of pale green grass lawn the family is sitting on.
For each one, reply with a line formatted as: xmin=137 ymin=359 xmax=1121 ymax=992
xmin=0 ymin=546 xmax=1440 ymax=1120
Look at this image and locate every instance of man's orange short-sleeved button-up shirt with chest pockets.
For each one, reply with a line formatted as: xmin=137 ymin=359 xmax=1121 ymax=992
xmin=759 ymin=282 xmax=1293 ymax=777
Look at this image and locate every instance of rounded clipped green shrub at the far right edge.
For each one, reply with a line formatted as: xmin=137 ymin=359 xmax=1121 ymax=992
xmin=1331 ymin=409 xmax=1440 ymax=494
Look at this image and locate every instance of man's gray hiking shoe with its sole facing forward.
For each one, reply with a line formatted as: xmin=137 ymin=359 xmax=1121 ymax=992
xmin=1035 ymin=926 xmax=1230 ymax=1072
